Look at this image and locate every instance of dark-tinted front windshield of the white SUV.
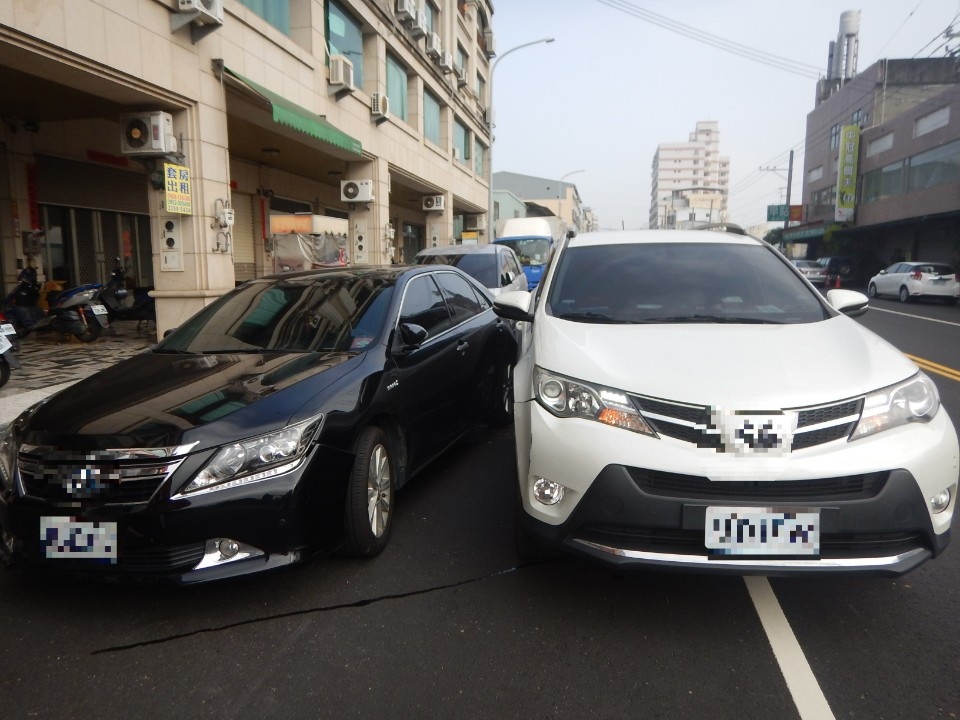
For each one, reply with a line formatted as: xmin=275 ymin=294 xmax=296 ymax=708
xmin=547 ymin=242 xmax=829 ymax=324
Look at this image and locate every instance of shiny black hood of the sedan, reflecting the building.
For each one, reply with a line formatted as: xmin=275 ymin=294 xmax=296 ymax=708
xmin=25 ymin=352 xmax=360 ymax=450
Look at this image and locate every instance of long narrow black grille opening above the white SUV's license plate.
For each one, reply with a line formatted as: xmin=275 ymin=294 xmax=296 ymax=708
xmin=627 ymin=468 xmax=889 ymax=503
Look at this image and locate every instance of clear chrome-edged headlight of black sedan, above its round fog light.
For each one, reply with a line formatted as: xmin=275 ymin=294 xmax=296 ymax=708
xmin=180 ymin=415 xmax=323 ymax=495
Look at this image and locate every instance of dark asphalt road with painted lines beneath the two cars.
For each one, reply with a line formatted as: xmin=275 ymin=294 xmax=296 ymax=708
xmin=0 ymin=300 xmax=960 ymax=720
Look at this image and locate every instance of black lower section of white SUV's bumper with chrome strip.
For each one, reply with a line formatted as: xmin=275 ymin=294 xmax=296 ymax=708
xmin=520 ymin=465 xmax=950 ymax=575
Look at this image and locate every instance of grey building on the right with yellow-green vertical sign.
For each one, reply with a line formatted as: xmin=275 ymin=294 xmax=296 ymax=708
xmin=784 ymin=58 xmax=960 ymax=281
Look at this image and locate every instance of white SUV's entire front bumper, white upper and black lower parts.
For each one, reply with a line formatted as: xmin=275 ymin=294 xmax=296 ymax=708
xmin=515 ymin=402 xmax=960 ymax=575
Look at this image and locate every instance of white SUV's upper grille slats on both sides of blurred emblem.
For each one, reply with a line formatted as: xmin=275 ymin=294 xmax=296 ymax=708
xmin=632 ymin=395 xmax=863 ymax=452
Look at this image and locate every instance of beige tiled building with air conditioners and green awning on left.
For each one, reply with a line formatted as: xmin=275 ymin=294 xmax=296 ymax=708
xmin=0 ymin=0 xmax=495 ymax=334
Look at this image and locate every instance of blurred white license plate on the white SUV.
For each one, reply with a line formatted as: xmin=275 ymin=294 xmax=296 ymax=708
xmin=704 ymin=507 xmax=820 ymax=555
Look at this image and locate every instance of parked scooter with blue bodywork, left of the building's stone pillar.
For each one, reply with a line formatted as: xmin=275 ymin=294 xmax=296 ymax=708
xmin=6 ymin=267 xmax=110 ymax=342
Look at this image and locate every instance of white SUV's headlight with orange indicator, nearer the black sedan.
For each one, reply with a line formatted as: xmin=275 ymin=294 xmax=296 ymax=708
xmin=533 ymin=367 xmax=657 ymax=437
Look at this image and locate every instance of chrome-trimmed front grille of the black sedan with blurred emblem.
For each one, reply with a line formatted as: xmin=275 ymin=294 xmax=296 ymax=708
xmin=18 ymin=451 xmax=183 ymax=508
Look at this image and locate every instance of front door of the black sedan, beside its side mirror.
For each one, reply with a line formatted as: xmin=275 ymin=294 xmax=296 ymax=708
xmin=388 ymin=273 xmax=465 ymax=471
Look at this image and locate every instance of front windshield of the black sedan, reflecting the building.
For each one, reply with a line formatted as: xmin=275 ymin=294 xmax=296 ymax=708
xmin=157 ymin=273 xmax=393 ymax=353
